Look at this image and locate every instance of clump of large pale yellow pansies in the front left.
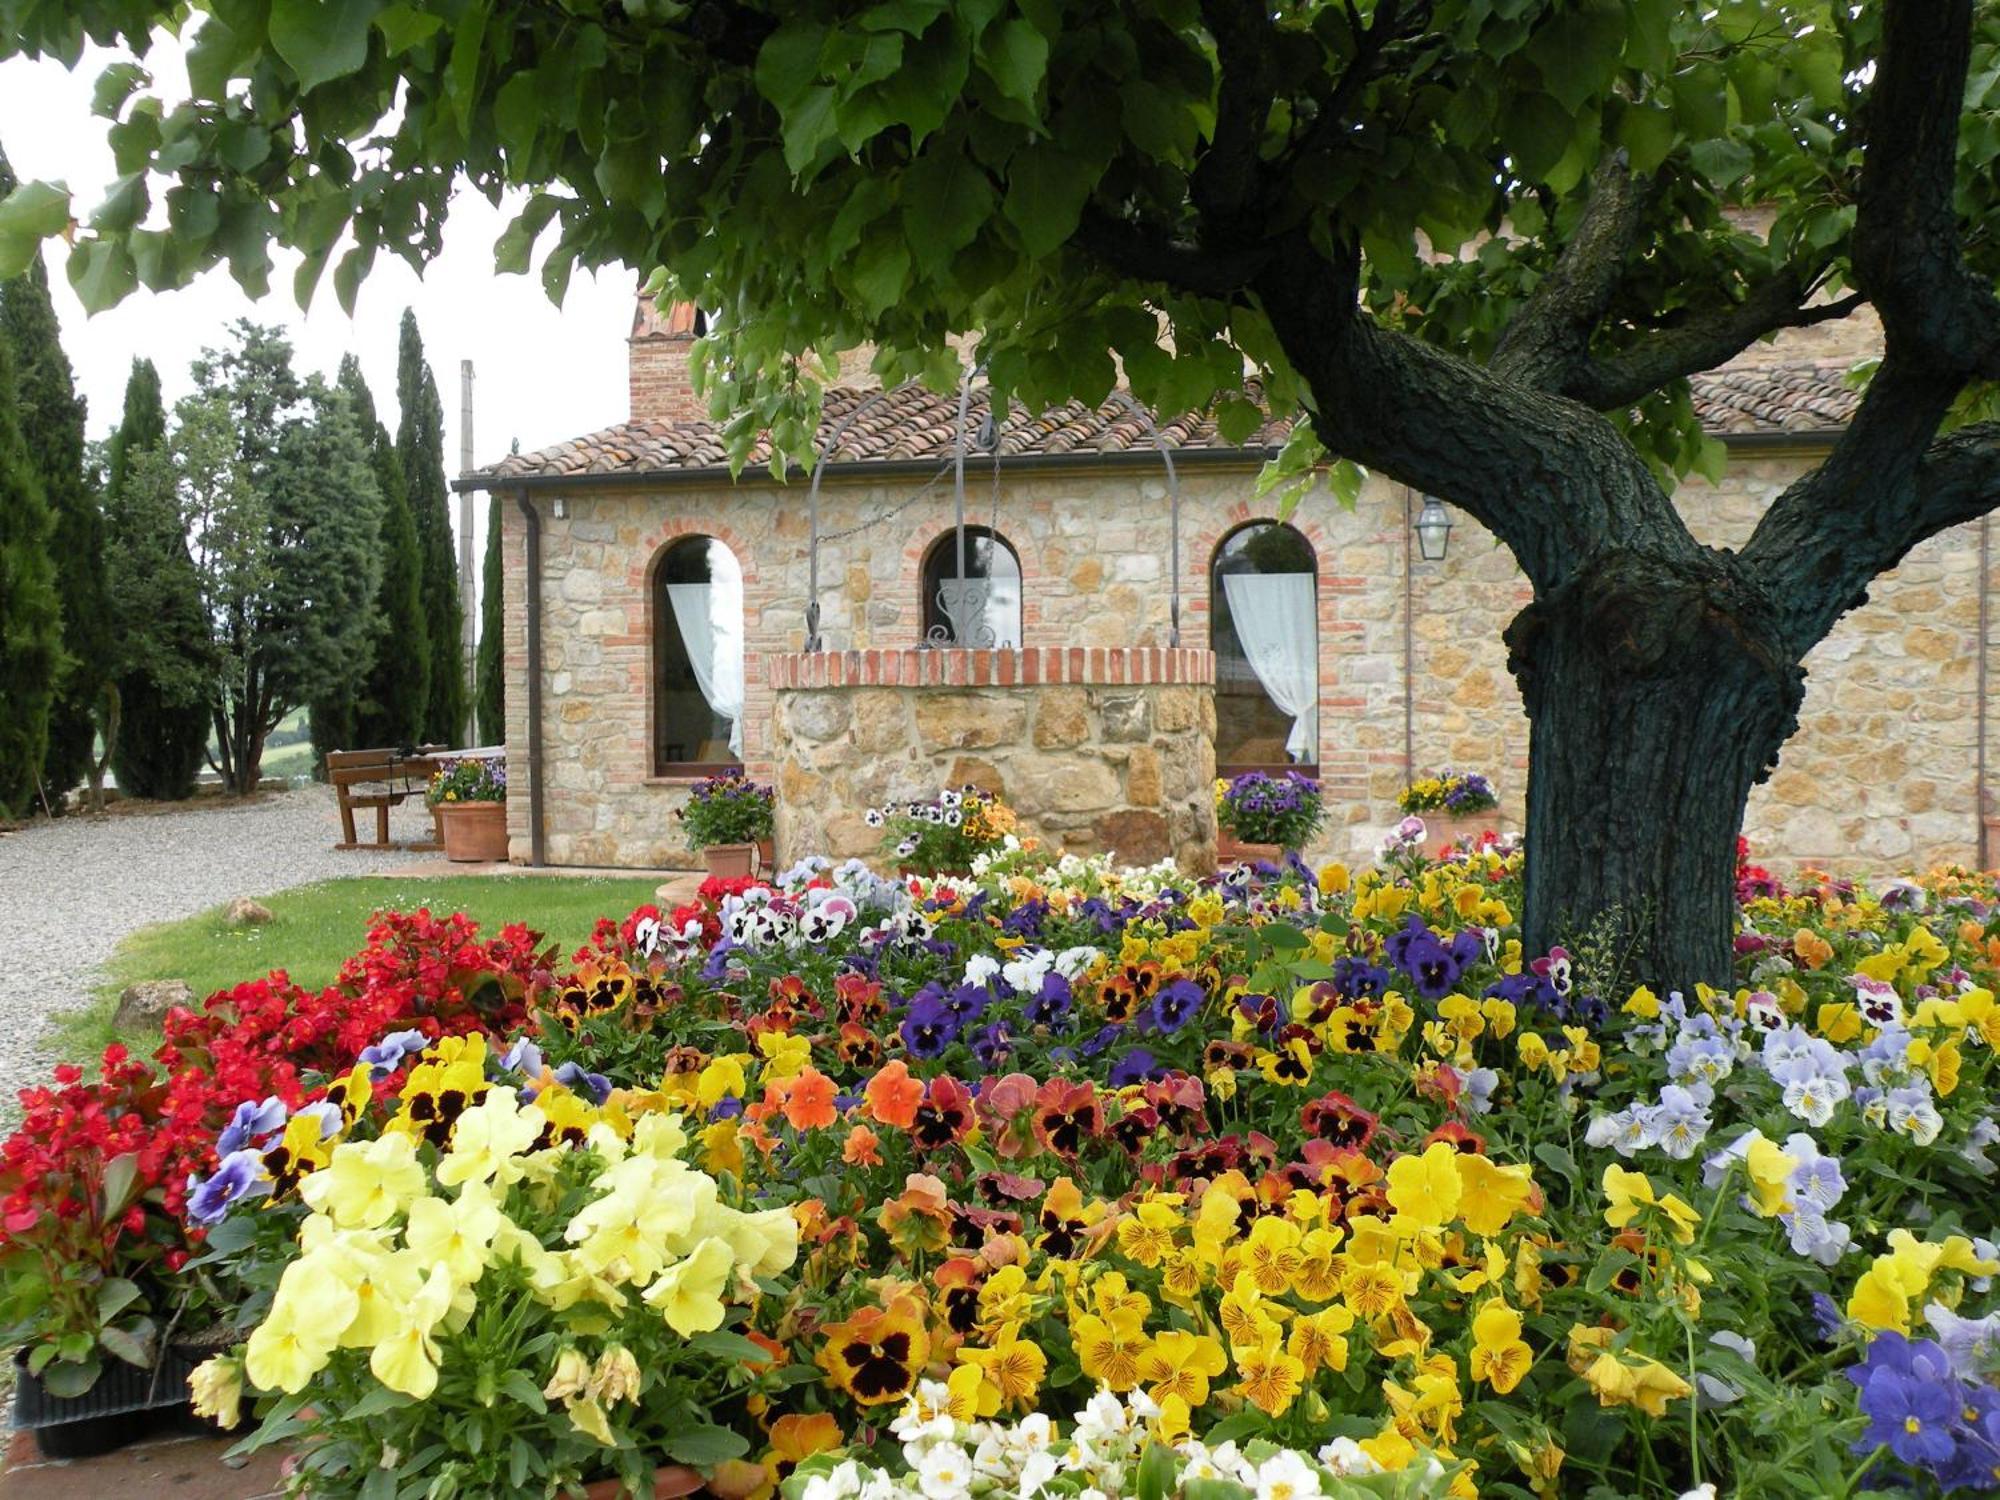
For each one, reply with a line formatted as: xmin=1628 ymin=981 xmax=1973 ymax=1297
xmin=192 ymin=1038 xmax=798 ymax=1500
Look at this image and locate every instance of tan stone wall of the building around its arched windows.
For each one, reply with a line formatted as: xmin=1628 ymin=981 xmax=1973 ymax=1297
xmin=502 ymin=396 xmax=1992 ymax=874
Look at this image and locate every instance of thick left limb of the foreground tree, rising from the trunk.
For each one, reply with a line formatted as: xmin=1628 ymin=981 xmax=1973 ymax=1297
xmin=1256 ymin=244 xmax=1700 ymax=594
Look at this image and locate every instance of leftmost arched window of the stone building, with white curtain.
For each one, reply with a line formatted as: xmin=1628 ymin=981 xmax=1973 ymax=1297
xmin=652 ymin=536 xmax=744 ymax=776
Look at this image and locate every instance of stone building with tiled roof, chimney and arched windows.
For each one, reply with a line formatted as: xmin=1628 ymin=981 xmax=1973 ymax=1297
xmin=466 ymin=302 xmax=1990 ymax=872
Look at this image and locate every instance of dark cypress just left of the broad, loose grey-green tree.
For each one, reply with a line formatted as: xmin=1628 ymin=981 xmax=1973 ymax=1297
xmin=104 ymin=360 xmax=214 ymax=802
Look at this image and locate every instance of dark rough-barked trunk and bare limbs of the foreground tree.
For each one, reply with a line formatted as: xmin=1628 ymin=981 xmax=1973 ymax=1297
xmin=1078 ymin=0 xmax=2000 ymax=986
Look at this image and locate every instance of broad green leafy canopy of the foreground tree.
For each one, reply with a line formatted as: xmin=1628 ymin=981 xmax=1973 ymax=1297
xmin=0 ymin=0 xmax=1936 ymax=482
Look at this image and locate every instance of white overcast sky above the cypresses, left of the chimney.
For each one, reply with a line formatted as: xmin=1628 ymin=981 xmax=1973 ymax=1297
xmin=0 ymin=42 xmax=638 ymax=552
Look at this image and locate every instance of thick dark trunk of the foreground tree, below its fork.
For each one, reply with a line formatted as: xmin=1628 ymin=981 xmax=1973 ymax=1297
xmin=1506 ymin=550 xmax=1804 ymax=1004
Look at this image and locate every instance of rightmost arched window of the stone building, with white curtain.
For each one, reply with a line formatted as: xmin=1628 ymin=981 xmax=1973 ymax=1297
xmin=1208 ymin=520 xmax=1320 ymax=774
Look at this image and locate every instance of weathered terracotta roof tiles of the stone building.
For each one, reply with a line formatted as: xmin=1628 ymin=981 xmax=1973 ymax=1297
xmin=484 ymin=364 xmax=1860 ymax=478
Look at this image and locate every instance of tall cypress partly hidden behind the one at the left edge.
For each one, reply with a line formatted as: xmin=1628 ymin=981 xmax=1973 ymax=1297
xmin=0 ymin=152 xmax=112 ymax=804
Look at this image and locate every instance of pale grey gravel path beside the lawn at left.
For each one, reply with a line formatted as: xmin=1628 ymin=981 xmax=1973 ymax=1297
xmin=0 ymin=786 xmax=436 ymax=1116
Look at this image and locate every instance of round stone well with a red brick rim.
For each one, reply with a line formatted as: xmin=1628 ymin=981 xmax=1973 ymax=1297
xmin=768 ymin=646 xmax=1216 ymax=870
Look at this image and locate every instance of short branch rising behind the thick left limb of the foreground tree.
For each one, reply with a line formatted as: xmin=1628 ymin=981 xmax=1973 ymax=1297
xmin=1492 ymin=150 xmax=1652 ymax=390
